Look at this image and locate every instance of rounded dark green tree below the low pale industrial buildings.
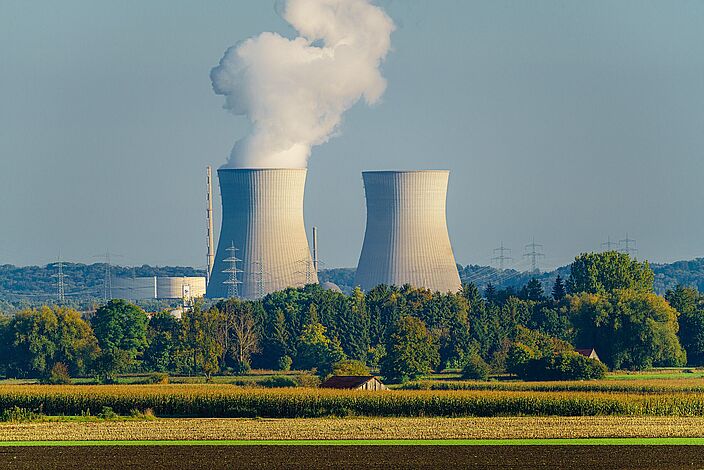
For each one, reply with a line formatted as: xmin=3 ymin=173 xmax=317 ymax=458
xmin=91 ymin=300 xmax=149 ymax=378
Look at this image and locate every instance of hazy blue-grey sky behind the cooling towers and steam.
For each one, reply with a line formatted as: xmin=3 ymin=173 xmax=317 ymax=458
xmin=0 ymin=0 xmax=704 ymax=268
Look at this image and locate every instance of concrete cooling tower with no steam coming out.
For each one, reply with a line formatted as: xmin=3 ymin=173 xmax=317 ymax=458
xmin=355 ymin=170 xmax=461 ymax=292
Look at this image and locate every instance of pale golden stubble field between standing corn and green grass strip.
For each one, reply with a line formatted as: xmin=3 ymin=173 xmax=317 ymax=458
xmin=0 ymin=416 xmax=704 ymax=441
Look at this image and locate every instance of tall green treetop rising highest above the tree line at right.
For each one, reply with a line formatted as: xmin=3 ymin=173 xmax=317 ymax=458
xmin=567 ymin=251 xmax=655 ymax=294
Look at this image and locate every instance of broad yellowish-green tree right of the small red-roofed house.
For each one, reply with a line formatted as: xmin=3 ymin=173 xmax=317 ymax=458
xmin=570 ymin=290 xmax=686 ymax=370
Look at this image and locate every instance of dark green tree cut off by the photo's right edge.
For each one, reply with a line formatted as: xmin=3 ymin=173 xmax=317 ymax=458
xmin=665 ymin=285 xmax=704 ymax=366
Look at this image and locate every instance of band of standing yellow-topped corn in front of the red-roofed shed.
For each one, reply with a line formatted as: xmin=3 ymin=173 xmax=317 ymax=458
xmin=0 ymin=385 xmax=704 ymax=418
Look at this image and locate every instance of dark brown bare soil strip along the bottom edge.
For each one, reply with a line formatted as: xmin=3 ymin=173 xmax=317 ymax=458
xmin=0 ymin=446 xmax=704 ymax=470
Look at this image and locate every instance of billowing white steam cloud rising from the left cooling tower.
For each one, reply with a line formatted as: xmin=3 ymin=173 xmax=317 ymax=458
xmin=210 ymin=0 xmax=394 ymax=168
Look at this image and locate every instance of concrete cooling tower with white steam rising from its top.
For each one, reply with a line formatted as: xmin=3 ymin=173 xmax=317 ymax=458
xmin=207 ymin=168 xmax=318 ymax=299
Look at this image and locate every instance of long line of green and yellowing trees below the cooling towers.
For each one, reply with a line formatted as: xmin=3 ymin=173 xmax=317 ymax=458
xmin=0 ymin=252 xmax=704 ymax=382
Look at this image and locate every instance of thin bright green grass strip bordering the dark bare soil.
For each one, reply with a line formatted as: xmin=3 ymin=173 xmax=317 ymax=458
xmin=0 ymin=437 xmax=704 ymax=447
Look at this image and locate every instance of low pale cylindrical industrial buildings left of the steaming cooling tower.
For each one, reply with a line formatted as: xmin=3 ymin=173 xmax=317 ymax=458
xmin=112 ymin=276 xmax=205 ymax=301
